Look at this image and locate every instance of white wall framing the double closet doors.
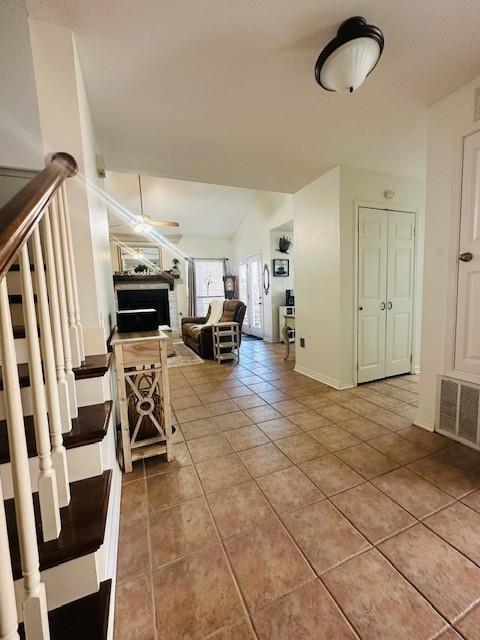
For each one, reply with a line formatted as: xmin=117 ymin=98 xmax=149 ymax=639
xmin=340 ymin=167 xmax=425 ymax=386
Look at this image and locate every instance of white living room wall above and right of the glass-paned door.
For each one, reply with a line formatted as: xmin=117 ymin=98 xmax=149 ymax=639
xmin=232 ymin=191 xmax=293 ymax=342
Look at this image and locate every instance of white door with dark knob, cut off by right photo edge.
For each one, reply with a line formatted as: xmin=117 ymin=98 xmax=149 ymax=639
xmin=455 ymin=132 xmax=480 ymax=375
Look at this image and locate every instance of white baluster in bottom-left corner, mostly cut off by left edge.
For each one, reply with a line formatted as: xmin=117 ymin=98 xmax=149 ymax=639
xmin=0 ymin=472 xmax=20 ymax=640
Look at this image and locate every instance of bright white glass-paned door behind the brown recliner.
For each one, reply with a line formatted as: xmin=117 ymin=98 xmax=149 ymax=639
xmin=239 ymin=255 xmax=263 ymax=338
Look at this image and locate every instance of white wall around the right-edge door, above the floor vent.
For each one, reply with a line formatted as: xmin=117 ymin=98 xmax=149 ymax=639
xmin=416 ymin=77 xmax=480 ymax=429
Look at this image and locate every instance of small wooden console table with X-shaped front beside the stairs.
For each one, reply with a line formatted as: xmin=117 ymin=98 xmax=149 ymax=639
xmin=111 ymin=330 xmax=173 ymax=473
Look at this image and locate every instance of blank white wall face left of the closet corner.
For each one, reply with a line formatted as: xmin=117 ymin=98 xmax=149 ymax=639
xmin=294 ymin=167 xmax=342 ymax=386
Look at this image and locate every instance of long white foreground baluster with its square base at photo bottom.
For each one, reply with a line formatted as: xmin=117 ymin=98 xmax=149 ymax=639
xmin=0 ymin=277 xmax=50 ymax=640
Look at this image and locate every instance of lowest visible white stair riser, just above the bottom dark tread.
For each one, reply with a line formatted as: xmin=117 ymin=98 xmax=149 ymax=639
xmin=15 ymin=548 xmax=101 ymax=622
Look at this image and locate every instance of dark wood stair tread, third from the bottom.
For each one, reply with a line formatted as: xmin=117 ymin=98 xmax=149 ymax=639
xmin=0 ymin=400 xmax=112 ymax=464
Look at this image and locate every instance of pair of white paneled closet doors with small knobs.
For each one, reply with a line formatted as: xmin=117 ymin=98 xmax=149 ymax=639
xmin=357 ymin=207 xmax=415 ymax=382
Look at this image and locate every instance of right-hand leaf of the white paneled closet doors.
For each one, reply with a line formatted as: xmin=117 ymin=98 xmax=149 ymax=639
xmin=385 ymin=211 xmax=415 ymax=376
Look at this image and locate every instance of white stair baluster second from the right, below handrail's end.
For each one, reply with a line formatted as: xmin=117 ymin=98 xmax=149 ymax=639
xmin=50 ymin=199 xmax=78 ymax=418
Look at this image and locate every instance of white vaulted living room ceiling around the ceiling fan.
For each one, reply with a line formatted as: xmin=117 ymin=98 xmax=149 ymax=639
xmin=105 ymin=171 xmax=256 ymax=238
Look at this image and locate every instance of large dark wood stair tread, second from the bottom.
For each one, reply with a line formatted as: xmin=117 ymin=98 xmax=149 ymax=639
xmin=4 ymin=470 xmax=112 ymax=580
